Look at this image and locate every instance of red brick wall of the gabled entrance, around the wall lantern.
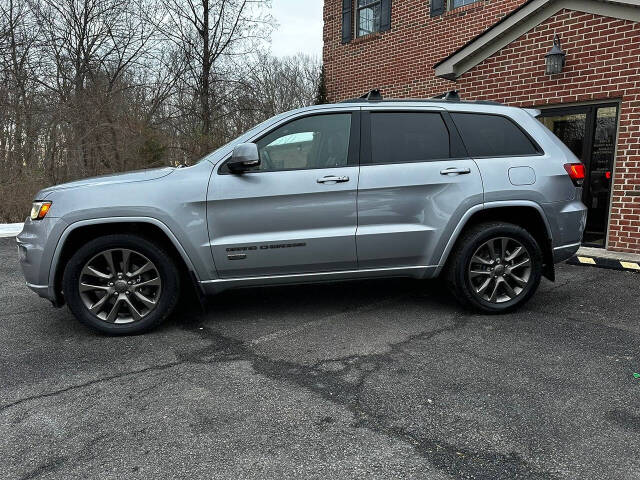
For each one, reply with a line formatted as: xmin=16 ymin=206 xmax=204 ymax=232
xmin=456 ymin=10 xmax=640 ymax=253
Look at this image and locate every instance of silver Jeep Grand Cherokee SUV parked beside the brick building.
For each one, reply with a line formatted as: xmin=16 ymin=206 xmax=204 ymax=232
xmin=17 ymin=96 xmax=586 ymax=334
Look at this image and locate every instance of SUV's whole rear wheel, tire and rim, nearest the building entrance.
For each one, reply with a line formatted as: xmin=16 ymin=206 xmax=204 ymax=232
xmin=446 ymin=222 xmax=542 ymax=313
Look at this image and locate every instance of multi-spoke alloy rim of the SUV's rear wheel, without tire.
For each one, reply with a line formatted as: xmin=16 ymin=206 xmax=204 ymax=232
xmin=468 ymin=237 xmax=531 ymax=303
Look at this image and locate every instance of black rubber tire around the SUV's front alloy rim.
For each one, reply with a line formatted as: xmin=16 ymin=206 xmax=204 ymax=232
xmin=62 ymin=234 xmax=180 ymax=335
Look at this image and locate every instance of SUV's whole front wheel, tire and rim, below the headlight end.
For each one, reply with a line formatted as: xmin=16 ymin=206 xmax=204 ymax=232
xmin=62 ymin=234 xmax=180 ymax=335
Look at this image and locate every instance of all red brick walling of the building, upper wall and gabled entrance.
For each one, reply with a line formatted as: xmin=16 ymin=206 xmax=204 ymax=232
xmin=324 ymin=0 xmax=640 ymax=253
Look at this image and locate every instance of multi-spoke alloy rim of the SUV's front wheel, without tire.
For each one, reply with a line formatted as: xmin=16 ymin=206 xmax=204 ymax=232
xmin=78 ymin=248 xmax=162 ymax=324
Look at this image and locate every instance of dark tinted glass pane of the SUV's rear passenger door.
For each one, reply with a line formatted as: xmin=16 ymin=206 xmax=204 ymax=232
xmin=371 ymin=112 xmax=450 ymax=164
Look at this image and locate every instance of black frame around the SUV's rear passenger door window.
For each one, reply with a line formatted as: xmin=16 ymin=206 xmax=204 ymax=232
xmin=360 ymin=108 xmax=470 ymax=166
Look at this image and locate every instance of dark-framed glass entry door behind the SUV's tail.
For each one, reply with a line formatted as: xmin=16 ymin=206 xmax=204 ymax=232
xmin=539 ymin=104 xmax=618 ymax=247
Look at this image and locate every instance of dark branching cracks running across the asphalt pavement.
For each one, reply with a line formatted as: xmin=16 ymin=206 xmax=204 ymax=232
xmin=0 ymin=314 xmax=556 ymax=480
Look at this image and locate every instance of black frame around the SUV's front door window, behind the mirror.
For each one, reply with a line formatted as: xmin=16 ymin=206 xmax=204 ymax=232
xmin=218 ymin=110 xmax=362 ymax=176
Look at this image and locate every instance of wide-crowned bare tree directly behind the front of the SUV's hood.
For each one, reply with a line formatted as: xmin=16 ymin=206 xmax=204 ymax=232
xmin=31 ymin=0 xmax=159 ymax=174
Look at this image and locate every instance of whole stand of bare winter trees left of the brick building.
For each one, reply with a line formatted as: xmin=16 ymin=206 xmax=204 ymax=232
xmin=0 ymin=0 xmax=319 ymax=222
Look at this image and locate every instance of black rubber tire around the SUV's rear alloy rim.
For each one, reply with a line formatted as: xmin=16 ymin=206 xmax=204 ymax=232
xmin=445 ymin=222 xmax=543 ymax=313
